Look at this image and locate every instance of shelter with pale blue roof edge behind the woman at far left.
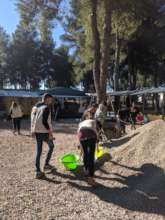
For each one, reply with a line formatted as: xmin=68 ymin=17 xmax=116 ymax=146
xmin=0 ymin=89 xmax=40 ymax=117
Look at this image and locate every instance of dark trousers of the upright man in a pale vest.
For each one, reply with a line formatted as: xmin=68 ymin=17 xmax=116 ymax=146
xmin=35 ymin=133 xmax=54 ymax=172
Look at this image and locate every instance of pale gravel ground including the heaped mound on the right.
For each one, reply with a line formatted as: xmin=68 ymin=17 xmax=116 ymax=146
xmin=0 ymin=120 xmax=165 ymax=220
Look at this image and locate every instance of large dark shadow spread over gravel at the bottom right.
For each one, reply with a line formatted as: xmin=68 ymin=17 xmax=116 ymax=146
xmin=69 ymin=162 xmax=165 ymax=216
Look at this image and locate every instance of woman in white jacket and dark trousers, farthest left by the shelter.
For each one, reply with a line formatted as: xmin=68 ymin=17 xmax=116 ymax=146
xmin=10 ymin=102 xmax=23 ymax=135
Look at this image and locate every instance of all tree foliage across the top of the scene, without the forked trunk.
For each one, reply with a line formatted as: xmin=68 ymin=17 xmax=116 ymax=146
xmin=0 ymin=0 xmax=165 ymax=90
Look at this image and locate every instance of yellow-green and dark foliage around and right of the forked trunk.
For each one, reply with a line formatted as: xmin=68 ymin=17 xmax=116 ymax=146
xmin=62 ymin=0 xmax=165 ymax=88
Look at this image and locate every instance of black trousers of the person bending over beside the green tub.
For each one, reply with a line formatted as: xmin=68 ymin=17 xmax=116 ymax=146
xmin=80 ymin=139 xmax=96 ymax=177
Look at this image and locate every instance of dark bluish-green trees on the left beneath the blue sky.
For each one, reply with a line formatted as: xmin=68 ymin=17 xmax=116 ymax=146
xmin=0 ymin=0 xmax=74 ymax=89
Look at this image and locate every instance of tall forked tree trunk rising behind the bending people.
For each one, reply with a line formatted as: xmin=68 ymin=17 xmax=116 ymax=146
xmin=90 ymin=0 xmax=111 ymax=103
